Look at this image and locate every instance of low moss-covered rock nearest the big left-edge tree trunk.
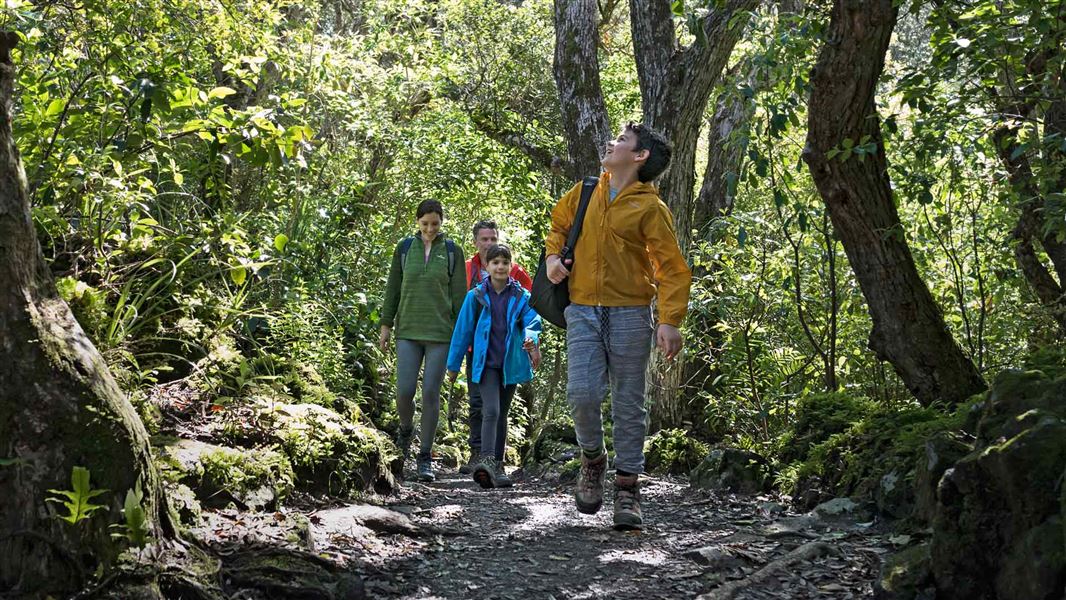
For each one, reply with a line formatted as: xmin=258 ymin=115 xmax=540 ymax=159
xmin=160 ymin=439 xmax=293 ymax=508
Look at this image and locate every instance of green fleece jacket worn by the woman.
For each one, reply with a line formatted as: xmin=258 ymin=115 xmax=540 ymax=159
xmin=382 ymin=233 xmax=466 ymax=343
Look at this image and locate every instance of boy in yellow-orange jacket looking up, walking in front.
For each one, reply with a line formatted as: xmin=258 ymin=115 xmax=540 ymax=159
xmin=545 ymin=124 xmax=692 ymax=530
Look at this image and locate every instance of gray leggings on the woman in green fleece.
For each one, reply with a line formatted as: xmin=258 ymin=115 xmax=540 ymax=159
xmin=397 ymin=340 xmax=448 ymax=460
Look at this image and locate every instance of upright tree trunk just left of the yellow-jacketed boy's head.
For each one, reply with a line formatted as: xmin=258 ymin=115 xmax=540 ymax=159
xmin=553 ymin=0 xmax=611 ymax=181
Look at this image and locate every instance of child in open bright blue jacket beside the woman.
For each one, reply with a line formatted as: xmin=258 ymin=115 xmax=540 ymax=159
xmin=448 ymin=245 xmax=540 ymax=488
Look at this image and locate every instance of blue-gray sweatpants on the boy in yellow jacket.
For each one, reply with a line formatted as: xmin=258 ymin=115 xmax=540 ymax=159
xmin=564 ymin=304 xmax=655 ymax=473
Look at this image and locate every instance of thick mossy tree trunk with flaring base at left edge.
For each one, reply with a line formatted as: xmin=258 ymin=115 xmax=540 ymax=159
xmin=0 ymin=32 xmax=174 ymax=594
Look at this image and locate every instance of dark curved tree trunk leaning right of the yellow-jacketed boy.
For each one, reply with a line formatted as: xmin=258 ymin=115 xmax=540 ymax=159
xmin=803 ymin=0 xmax=985 ymax=405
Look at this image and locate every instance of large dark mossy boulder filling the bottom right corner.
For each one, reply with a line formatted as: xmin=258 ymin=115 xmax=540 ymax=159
xmin=933 ymin=413 xmax=1066 ymax=600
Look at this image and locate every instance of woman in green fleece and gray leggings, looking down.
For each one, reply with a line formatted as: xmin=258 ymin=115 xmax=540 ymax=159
xmin=379 ymin=200 xmax=466 ymax=482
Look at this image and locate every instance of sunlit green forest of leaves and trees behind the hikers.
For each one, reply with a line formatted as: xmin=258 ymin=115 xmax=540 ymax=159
xmin=0 ymin=0 xmax=1066 ymax=596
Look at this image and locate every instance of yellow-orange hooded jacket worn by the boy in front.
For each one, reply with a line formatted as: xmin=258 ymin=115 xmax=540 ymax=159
xmin=545 ymin=173 xmax=692 ymax=327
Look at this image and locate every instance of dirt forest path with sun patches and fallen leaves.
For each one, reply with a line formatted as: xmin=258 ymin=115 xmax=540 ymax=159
xmin=334 ymin=471 xmax=890 ymax=600
